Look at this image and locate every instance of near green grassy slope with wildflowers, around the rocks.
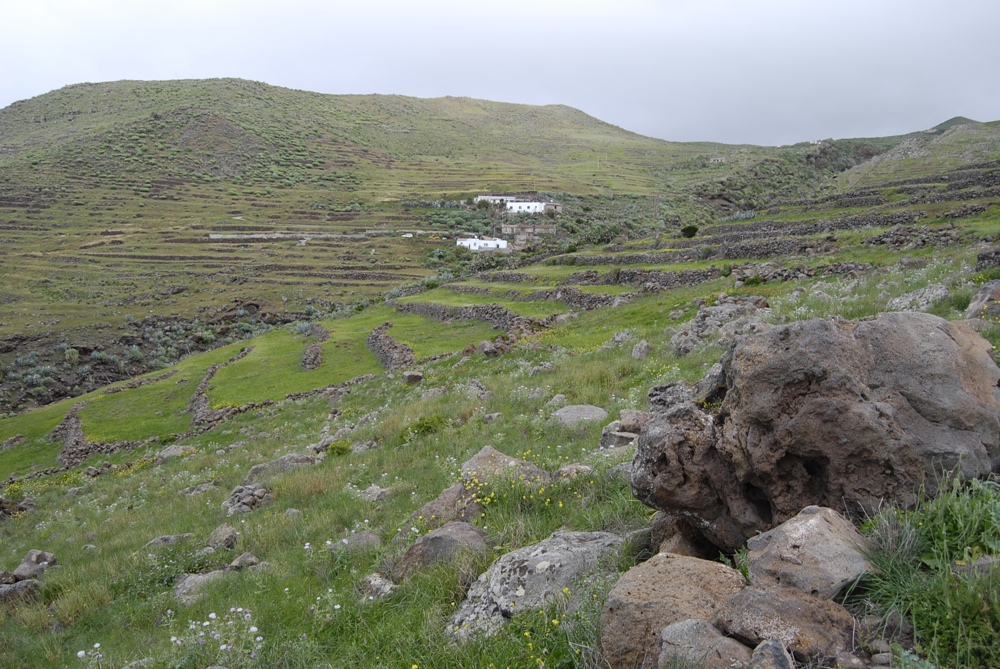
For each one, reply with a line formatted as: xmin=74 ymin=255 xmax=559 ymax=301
xmin=0 ymin=185 xmax=1000 ymax=667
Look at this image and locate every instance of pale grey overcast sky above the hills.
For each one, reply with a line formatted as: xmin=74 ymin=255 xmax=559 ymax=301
xmin=0 ymin=0 xmax=1000 ymax=144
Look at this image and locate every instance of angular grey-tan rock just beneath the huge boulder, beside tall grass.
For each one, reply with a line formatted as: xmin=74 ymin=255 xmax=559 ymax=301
xmin=747 ymin=506 xmax=871 ymax=599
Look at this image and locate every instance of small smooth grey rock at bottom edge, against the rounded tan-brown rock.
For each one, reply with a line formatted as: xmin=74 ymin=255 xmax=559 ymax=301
xmin=657 ymin=618 xmax=750 ymax=669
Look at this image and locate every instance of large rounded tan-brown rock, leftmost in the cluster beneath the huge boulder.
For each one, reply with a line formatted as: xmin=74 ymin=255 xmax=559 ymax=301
xmin=601 ymin=553 xmax=746 ymax=669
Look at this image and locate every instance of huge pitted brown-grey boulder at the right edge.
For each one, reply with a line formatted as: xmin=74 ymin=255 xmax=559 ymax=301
xmin=632 ymin=312 xmax=1000 ymax=550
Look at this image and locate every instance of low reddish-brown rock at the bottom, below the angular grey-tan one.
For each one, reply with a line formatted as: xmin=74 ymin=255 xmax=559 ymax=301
xmin=711 ymin=585 xmax=854 ymax=662
